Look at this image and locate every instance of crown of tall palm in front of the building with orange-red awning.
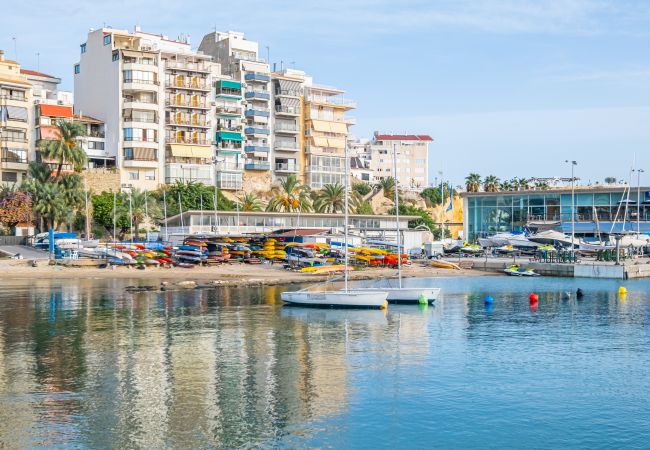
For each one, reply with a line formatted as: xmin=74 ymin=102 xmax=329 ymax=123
xmin=40 ymin=120 xmax=86 ymax=178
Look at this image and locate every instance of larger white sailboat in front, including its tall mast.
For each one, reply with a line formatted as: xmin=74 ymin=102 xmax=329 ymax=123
xmin=280 ymin=143 xmax=388 ymax=308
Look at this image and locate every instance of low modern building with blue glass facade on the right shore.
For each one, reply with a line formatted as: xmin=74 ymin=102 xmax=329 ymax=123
xmin=463 ymin=186 xmax=650 ymax=241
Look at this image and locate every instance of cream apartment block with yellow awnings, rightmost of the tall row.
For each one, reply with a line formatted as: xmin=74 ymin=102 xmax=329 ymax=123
xmin=303 ymin=84 xmax=356 ymax=189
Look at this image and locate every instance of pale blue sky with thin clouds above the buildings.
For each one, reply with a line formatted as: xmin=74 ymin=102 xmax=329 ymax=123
xmin=5 ymin=0 xmax=650 ymax=185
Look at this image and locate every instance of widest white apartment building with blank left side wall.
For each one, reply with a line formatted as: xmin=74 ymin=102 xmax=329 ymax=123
xmin=74 ymin=27 xmax=220 ymax=190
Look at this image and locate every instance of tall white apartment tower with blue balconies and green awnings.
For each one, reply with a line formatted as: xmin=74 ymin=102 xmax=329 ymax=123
xmin=199 ymin=31 xmax=272 ymax=190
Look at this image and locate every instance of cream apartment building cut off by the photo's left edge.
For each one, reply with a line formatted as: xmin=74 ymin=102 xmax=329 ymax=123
xmin=0 ymin=50 xmax=34 ymax=184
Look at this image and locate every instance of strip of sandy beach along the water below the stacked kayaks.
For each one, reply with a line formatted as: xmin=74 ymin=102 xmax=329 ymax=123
xmin=0 ymin=260 xmax=494 ymax=286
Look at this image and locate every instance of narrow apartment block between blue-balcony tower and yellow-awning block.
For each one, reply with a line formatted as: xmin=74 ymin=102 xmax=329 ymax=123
xmin=271 ymin=69 xmax=310 ymax=182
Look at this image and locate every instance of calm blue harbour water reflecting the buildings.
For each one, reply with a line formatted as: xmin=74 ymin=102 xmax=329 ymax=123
xmin=0 ymin=277 xmax=650 ymax=448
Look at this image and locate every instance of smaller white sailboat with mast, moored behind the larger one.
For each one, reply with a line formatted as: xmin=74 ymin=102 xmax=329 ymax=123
xmin=345 ymin=144 xmax=444 ymax=303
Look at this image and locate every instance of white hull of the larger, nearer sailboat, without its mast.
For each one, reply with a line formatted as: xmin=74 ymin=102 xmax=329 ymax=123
xmin=281 ymin=290 xmax=388 ymax=308
